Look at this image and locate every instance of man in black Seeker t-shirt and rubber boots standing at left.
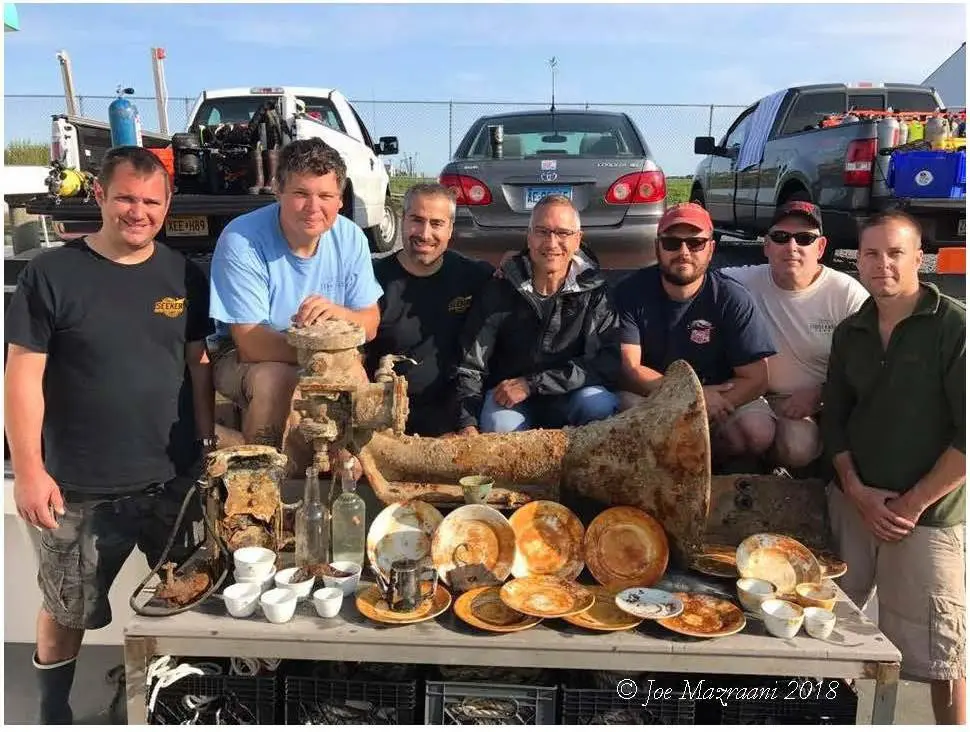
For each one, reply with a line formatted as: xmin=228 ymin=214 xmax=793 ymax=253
xmin=5 ymin=147 xmax=215 ymax=724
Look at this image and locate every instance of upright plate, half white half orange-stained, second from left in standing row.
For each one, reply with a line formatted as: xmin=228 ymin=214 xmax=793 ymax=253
xmin=431 ymin=504 xmax=515 ymax=592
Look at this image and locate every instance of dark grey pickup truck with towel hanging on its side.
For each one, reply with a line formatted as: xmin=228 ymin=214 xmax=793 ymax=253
xmin=691 ymin=84 xmax=966 ymax=266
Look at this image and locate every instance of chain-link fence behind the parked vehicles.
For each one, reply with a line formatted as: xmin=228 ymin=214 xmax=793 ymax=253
xmin=4 ymin=94 xmax=744 ymax=177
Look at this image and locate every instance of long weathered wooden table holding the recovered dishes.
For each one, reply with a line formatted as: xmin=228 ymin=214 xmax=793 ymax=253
xmin=125 ymin=590 xmax=900 ymax=724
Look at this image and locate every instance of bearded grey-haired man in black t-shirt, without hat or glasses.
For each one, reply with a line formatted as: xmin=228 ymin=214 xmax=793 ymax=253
xmin=367 ymin=183 xmax=492 ymax=437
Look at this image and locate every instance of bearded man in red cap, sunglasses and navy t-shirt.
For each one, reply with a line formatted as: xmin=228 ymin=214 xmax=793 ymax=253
xmin=616 ymin=203 xmax=775 ymax=460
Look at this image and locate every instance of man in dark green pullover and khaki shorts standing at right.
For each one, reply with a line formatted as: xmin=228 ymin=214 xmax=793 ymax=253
xmin=822 ymin=212 xmax=966 ymax=724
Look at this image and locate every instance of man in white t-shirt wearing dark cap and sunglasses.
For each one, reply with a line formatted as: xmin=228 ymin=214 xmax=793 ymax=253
xmin=721 ymin=201 xmax=869 ymax=468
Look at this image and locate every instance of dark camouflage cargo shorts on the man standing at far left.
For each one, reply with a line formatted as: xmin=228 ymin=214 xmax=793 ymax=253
xmin=37 ymin=478 xmax=201 ymax=630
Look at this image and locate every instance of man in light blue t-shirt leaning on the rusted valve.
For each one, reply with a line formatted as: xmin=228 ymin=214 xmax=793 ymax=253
xmin=210 ymin=134 xmax=383 ymax=449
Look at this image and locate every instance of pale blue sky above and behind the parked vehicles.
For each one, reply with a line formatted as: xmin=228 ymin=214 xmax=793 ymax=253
xmin=4 ymin=3 xmax=966 ymax=175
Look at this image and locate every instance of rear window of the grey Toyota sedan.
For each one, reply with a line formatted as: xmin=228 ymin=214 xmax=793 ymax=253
xmin=460 ymin=112 xmax=645 ymax=160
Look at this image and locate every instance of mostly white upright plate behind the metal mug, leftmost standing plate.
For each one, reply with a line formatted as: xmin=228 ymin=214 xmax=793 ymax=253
xmin=367 ymin=501 xmax=441 ymax=578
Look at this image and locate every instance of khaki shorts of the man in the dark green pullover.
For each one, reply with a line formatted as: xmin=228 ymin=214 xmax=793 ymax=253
xmin=826 ymin=484 xmax=966 ymax=681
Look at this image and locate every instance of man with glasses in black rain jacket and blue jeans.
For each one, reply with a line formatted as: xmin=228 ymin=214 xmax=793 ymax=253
xmin=458 ymin=196 xmax=619 ymax=434
